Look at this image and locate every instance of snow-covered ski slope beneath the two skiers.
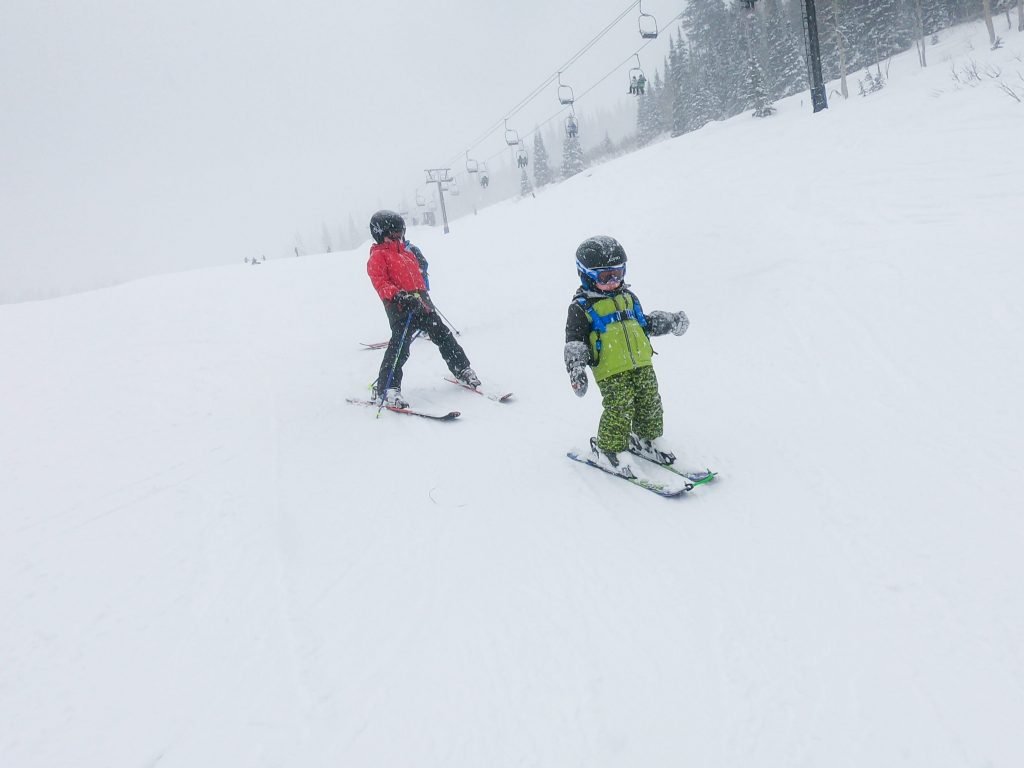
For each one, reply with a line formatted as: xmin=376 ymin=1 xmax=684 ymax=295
xmin=0 ymin=20 xmax=1024 ymax=768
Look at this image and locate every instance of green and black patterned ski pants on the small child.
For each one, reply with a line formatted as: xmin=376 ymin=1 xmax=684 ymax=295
xmin=597 ymin=366 xmax=665 ymax=454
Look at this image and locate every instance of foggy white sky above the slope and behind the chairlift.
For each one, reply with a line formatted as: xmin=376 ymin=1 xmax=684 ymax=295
xmin=0 ymin=0 xmax=682 ymax=301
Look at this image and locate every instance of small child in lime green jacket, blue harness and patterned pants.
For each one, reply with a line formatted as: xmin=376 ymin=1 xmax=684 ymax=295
xmin=565 ymin=236 xmax=690 ymax=476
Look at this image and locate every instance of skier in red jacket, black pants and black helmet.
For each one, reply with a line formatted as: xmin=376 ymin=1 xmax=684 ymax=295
xmin=367 ymin=210 xmax=480 ymax=408
